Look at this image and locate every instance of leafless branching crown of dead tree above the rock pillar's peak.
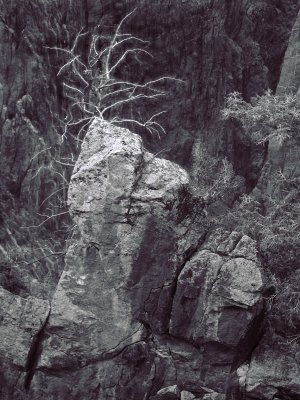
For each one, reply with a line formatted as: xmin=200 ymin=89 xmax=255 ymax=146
xmin=52 ymin=11 xmax=180 ymax=144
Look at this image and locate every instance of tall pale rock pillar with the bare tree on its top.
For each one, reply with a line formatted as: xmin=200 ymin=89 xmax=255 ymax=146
xmin=39 ymin=120 xmax=188 ymax=369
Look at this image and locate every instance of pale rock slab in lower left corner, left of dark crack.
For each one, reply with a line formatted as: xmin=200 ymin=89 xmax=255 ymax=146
xmin=0 ymin=288 xmax=50 ymax=399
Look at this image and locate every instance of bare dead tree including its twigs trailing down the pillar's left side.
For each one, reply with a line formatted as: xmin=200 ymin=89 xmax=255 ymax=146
xmin=28 ymin=11 xmax=182 ymax=227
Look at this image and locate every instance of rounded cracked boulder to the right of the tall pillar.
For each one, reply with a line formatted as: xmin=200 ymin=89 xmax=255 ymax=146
xmin=170 ymin=231 xmax=263 ymax=393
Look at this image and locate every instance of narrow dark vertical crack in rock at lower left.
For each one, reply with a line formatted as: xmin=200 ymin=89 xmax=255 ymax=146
xmin=24 ymin=304 xmax=51 ymax=391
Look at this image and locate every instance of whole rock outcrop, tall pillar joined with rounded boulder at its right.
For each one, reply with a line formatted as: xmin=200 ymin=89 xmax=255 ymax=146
xmin=0 ymin=120 xmax=263 ymax=400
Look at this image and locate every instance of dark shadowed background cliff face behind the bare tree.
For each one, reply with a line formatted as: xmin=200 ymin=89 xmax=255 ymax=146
xmin=0 ymin=0 xmax=298 ymax=299
